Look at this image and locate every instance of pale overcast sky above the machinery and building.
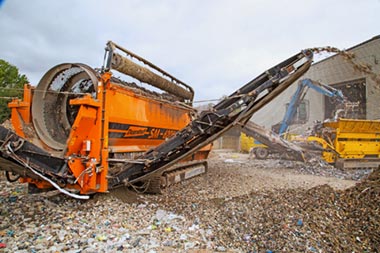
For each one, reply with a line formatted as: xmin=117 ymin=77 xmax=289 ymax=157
xmin=0 ymin=0 xmax=380 ymax=100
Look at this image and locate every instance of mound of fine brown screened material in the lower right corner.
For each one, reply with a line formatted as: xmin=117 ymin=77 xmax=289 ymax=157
xmin=156 ymin=167 xmax=380 ymax=252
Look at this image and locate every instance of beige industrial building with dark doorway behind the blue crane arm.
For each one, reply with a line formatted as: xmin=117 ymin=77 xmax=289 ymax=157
xmin=252 ymin=36 xmax=380 ymax=134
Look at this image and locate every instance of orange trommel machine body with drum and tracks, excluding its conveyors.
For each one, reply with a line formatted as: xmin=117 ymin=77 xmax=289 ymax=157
xmin=4 ymin=42 xmax=211 ymax=197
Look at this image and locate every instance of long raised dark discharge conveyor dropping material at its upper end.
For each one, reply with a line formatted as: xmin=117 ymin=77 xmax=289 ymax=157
xmin=109 ymin=50 xmax=313 ymax=187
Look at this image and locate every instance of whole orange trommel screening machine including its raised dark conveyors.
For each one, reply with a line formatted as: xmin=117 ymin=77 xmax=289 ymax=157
xmin=0 ymin=42 xmax=313 ymax=198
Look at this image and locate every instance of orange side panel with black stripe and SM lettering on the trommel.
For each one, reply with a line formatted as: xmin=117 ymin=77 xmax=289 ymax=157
xmin=105 ymin=84 xmax=191 ymax=152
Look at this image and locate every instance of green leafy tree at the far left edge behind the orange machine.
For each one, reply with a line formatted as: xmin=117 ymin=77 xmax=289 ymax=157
xmin=0 ymin=59 xmax=29 ymax=122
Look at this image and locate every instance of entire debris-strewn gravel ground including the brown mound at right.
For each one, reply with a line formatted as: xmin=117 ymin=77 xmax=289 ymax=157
xmin=0 ymin=153 xmax=380 ymax=253
